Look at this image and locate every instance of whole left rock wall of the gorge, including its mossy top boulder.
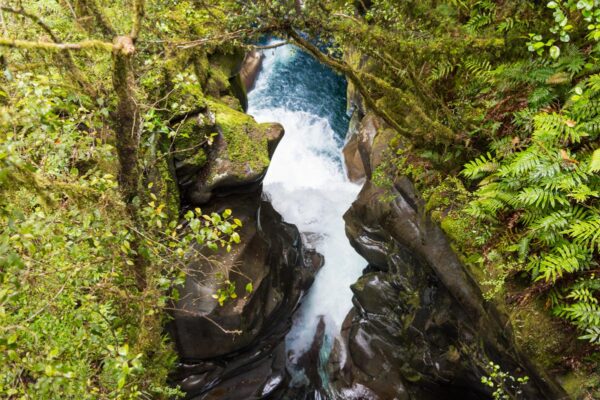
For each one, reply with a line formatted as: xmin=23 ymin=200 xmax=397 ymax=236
xmin=168 ymin=102 xmax=323 ymax=400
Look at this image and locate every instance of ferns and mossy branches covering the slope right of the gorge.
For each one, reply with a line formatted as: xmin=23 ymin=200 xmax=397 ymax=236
xmin=230 ymin=0 xmax=600 ymax=397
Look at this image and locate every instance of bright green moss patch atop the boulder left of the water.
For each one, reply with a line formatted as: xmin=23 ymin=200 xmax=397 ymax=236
xmin=209 ymin=100 xmax=270 ymax=172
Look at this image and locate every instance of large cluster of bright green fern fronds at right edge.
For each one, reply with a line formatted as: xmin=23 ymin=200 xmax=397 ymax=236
xmin=461 ymin=71 xmax=600 ymax=343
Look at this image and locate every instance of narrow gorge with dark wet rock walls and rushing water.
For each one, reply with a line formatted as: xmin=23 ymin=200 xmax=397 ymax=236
xmin=172 ymin=40 xmax=566 ymax=400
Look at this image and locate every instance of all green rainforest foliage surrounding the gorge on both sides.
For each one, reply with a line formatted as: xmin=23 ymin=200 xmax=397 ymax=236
xmin=0 ymin=0 xmax=600 ymax=399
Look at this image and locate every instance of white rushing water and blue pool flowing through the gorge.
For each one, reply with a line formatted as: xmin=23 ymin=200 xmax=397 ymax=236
xmin=248 ymin=46 xmax=366 ymax=372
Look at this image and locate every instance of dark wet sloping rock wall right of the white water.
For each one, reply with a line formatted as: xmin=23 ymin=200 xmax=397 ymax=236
xmin=329 ymin=178 xmax=568 ymax=400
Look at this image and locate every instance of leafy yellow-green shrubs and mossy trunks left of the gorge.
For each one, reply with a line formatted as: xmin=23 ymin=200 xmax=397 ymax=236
xmin=0 ymin=1 xmax=252 ymax=399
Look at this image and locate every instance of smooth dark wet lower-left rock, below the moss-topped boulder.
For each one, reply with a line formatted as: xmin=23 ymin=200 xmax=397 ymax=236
xmin=169 ymin=191 xmax=322 ymax=399
